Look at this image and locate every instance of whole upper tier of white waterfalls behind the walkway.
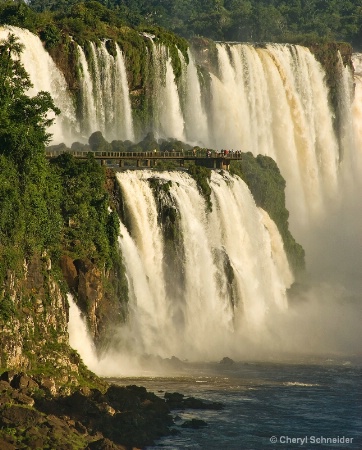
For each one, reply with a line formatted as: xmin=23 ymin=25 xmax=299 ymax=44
xmin=3 ymin=27 xmax=352 ymax=229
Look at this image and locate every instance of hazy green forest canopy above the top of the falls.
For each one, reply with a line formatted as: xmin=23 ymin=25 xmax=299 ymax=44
xmin=19 ymin=0 xmax=362 ymax=47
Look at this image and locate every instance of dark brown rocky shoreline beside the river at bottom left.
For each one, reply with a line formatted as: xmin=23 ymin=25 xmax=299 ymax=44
xmin=0 ymin=371 xmax=222 ymax=450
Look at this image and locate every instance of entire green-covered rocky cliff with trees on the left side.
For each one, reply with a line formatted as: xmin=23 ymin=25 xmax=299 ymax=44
xmin=0 ymin=35 xmax=127 ymax=376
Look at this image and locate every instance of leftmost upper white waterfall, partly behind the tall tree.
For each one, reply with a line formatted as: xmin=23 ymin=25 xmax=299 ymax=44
xmin=0 ymin=26 xmax=78 ymax=143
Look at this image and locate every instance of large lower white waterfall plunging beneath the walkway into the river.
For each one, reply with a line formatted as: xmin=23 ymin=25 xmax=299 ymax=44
xmin=106 ymin=171 xmax=293 ymax=359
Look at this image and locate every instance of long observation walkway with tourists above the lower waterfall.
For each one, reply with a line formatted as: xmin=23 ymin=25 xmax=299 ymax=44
xmin=46 ymin=149 xmax=242 ymax=170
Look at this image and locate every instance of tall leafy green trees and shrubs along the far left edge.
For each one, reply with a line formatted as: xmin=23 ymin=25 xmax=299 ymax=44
xmin=0 ymin=34 xmax=61 ymax=282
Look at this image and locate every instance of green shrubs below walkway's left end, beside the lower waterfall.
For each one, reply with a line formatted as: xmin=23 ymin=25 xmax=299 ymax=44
xmin=51 ymin=153 xmax=119 ymax=268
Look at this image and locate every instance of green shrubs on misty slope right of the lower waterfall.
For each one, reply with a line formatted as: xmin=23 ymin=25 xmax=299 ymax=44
xmin=230 ymin=152 xmax=305 ymax=274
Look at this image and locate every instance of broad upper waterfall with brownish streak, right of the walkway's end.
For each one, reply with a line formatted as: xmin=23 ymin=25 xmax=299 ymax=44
xmin=208 ymin=44 xmax=338 ymax=230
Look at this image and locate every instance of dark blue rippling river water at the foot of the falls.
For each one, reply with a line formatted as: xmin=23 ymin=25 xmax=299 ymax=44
xmin=108 ymin=358 xmax=362 ymax=450
